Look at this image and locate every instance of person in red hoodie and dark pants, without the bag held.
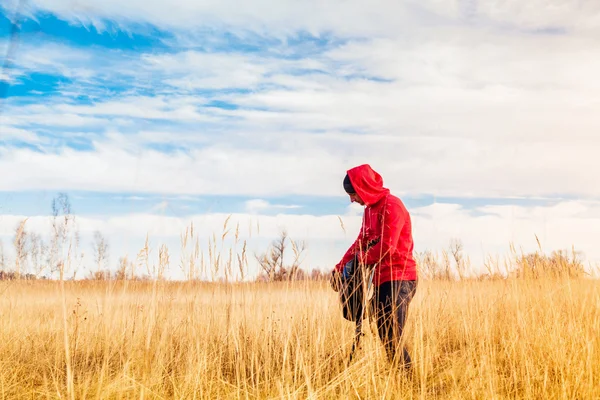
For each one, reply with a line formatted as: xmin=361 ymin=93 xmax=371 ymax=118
xmin=332 ymin=164 xmax=418 ymax=368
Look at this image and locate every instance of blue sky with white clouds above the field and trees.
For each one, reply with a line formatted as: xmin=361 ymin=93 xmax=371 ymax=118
xmin=0 ymin=0 xmax=600 ymax=276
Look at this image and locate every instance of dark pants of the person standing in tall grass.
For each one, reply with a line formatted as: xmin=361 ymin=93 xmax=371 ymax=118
xmin=373 ymin=281 xmax=417 ymax=368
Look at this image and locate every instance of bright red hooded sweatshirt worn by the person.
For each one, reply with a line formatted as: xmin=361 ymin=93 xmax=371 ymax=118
xmin=335 ymin=164 xmax=417 ymax=286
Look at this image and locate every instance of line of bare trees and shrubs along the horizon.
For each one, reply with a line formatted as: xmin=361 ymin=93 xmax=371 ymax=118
xmin=0 ymin=193 xmax=586 ymax=282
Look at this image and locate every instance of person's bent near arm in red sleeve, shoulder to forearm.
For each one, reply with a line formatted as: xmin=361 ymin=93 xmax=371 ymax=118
xmin=358 ymin=203 xmax=406 ymax=265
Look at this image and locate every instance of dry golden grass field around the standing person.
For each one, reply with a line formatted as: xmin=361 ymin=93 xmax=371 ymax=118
xmin=0 ymin=279 xmax=600 ymax=399
